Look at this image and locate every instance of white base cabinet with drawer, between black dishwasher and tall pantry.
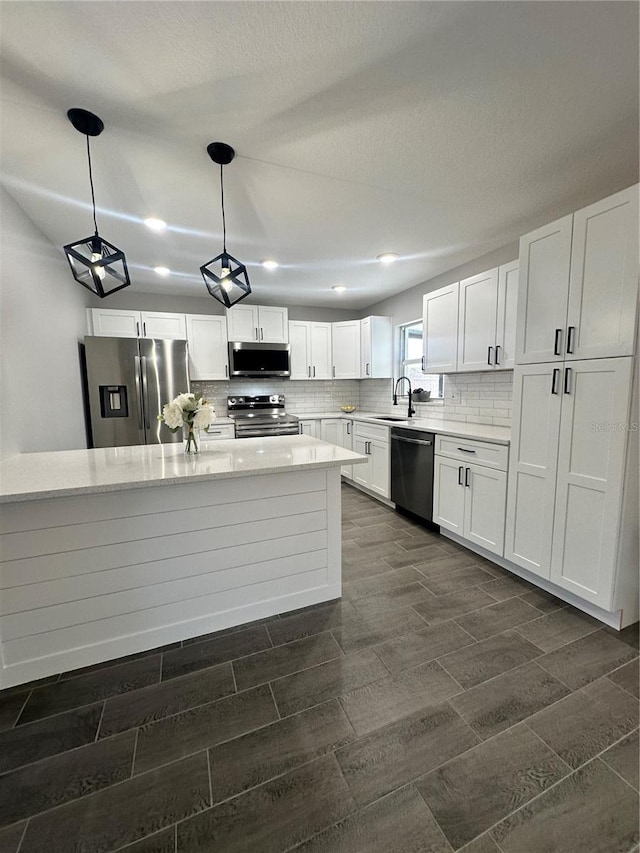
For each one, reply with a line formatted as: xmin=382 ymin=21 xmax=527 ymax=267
xmin=433 ymin=455 xmax=507 ymax=556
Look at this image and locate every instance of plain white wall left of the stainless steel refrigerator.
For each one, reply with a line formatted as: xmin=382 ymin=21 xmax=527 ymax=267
xmin=0 ymin=187 xmax=91 ymax=458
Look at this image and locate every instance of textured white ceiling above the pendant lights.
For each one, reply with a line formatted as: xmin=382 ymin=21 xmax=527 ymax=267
xmin=0 ymin=0 xmax=638 ymax=308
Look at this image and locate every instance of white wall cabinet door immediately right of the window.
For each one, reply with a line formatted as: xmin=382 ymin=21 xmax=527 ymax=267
xmin=422 ymin=282 xmax=458 ymax=373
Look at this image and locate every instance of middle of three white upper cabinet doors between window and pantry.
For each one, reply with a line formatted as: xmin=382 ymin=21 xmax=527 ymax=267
xmin=458 ymin=267 xmax=498 ymax=371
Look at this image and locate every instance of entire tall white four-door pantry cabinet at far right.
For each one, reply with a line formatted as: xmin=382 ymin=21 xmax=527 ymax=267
xmin=505 ymin=186 xmax=639 ymax=627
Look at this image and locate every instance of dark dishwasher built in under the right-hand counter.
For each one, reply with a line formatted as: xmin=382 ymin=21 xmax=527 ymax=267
xmin=391 ymin=427 xmax=434 ymax=522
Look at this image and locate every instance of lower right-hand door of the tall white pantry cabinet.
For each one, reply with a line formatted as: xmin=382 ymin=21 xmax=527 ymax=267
xmin=551 ymin=358 xmax=637 ymax=610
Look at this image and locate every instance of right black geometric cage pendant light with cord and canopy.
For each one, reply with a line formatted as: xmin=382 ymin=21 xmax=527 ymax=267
xmin=200 ymin=142 xmax=251 ymax=308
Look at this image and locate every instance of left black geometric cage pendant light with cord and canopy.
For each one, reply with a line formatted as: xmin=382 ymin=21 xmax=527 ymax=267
xmin=64 ymin=109 xmax=131 ymax=299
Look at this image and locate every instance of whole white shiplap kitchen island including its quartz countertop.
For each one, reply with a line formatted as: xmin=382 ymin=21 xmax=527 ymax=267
xmin=0 ymin=435 xmax=367 ymax=689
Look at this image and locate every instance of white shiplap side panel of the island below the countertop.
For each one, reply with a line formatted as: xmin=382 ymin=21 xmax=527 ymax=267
xmin=0 ymin=468 xmax=341 ymax=688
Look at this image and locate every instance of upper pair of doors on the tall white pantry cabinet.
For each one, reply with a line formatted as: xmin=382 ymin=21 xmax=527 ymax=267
xmin=516 ymin=186 xmax=638 ymax=364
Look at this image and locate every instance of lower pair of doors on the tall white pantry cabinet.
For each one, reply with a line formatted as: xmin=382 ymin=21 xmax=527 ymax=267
xmin=505 ymin=358 xmax=638 ymax=611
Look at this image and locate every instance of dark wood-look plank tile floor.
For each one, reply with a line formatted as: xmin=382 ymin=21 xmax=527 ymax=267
xmin=0 ymin=487 xmax=639 ymax=853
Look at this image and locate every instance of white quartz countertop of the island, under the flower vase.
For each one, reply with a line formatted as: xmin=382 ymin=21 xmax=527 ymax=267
xmin=0 ymin=435 xmax=369 ymax=503
